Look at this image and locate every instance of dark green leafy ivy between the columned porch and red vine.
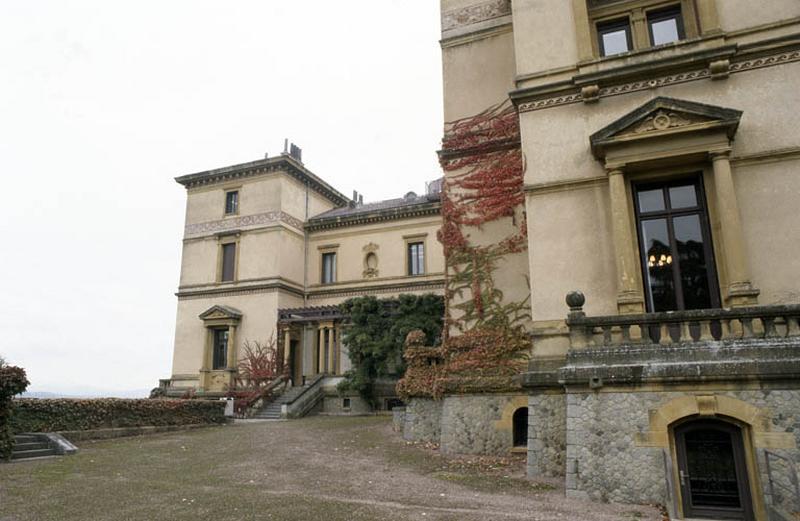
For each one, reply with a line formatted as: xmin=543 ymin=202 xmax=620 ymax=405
xmin=338 ymin=294 xmax=444 ymax=406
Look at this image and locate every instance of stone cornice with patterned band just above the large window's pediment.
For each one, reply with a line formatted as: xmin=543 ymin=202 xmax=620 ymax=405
xmin=509 ymin=35 xmax=800 ymax=113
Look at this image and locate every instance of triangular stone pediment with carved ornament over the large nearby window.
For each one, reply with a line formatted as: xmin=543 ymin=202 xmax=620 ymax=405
xmin=589 ymin=97 xmax=742 ymax=159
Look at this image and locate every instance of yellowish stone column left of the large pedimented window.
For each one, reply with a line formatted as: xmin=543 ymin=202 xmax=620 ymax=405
xmin=608 ymin=169 xmax=644 ymax=315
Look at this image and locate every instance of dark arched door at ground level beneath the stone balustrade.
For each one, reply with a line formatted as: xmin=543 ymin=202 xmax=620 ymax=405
xmin=674 ymin=419 xmax=754 ymax=520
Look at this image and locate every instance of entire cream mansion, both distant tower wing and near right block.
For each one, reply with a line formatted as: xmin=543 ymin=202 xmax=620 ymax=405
xmin=168 ymin=0 xmax=800 ymax=520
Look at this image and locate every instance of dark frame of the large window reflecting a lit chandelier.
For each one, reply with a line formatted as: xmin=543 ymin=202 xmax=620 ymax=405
xmin=632 ymin=172 xmax=722 ymax=313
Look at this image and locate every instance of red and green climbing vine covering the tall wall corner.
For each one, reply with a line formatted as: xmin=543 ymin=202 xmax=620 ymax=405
xmin=398 ymin=102 xmax=530 ymax=398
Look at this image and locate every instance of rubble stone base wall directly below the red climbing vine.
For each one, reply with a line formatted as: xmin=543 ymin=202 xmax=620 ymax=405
xmin=403 ymin=395 xmax=528 ymax=455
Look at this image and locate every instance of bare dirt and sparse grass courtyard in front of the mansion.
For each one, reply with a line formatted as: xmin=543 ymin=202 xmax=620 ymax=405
xmin=0 ymin=417 xmax=660 ymax=521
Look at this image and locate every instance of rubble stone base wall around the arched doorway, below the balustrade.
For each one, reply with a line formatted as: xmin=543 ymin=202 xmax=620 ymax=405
xmin=560 ymin=390 xmax=800 ymax=504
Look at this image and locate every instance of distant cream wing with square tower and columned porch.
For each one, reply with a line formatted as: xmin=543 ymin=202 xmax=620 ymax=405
xmin=162 ymin=149 xmax=443 ymax=406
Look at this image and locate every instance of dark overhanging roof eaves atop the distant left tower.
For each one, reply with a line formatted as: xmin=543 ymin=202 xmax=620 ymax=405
xmin=175 ymin=154 xmax=350 ymax=206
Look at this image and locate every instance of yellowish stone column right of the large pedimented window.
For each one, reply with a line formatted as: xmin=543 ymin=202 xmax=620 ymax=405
xmin=710 ymin=149 xmax=759 ymax=307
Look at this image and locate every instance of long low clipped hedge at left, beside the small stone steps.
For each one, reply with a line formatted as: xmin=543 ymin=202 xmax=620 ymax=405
xmin=11 ymin=398 xmax=225 ymax=433
